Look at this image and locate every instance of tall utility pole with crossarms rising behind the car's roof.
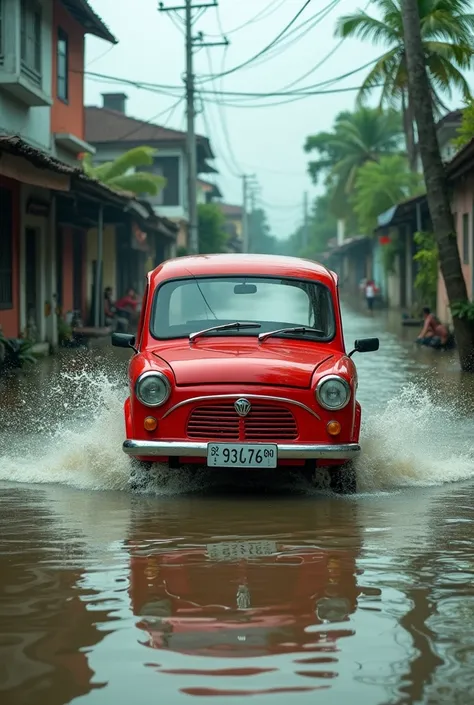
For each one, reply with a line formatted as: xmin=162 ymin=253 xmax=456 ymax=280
xmin=159 ymin=0 xmax=229 ymax=254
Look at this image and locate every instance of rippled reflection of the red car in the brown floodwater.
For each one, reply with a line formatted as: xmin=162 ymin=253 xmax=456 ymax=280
xmin=129 ymin=538 xmax=363 ymax=658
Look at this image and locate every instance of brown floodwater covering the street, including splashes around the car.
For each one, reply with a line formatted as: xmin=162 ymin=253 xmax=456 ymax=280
xmin=0 ymin=309 xmax=474 ymax=705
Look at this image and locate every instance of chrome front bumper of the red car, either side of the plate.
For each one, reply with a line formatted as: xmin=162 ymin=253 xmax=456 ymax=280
xmin=123 ymin=439 xmax=360 ymax=460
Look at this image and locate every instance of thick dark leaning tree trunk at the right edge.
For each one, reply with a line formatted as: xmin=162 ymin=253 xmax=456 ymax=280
xmin=402 ymin=0 xmax=474 ymax=372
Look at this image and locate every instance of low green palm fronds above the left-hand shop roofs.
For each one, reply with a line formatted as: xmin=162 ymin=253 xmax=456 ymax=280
xmin=82 ymin=147 xmax=166 ymax=196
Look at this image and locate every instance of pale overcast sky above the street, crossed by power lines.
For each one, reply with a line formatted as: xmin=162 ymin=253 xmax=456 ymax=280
xmin=86 ymin=0 xmax=466 ymax=238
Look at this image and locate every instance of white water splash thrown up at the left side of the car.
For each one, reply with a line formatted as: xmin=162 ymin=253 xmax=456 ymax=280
xmin=0 ymin=360 xmax=130 ymax=490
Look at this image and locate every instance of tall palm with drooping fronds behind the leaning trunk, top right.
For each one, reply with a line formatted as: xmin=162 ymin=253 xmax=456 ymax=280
xmin=336 ymin=0 xmax=474 ymax=170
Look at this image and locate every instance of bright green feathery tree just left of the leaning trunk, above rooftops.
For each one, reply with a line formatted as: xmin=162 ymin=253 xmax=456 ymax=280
xmin=352 ymin=155 xmax=423 ymax=235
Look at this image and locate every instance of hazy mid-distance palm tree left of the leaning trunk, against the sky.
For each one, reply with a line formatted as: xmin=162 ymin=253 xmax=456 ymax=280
xmin=304 ymin=107 xmax=403 ymax=219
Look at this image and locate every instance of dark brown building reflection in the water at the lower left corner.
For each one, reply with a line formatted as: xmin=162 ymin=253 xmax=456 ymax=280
xmin=0 ymin=490 xmax=110 ymax=705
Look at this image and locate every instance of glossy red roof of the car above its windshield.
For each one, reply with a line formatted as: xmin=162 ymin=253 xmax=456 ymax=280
xmin=150 ymin=254 xmax=337 ymax=286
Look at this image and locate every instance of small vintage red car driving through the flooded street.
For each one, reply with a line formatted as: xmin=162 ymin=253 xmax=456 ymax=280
xmin=112 ymin=254 xmax=379 ymax=492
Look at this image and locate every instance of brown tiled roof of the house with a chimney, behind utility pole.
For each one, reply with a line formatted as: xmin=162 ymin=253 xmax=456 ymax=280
xmin=85 ymin=106 xmax=214 ymax=159
